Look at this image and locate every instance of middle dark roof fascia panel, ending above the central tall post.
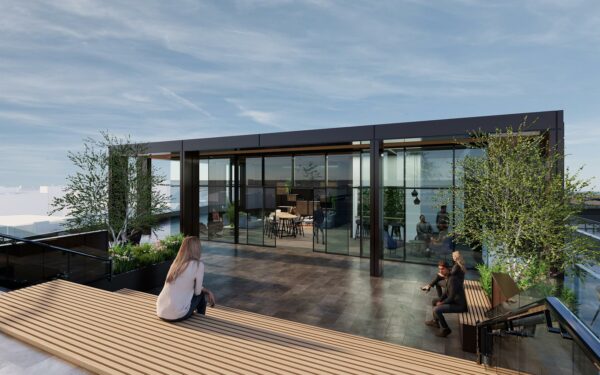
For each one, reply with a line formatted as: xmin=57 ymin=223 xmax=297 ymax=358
xmin=260 ymin=126 xmax=373 ymax=147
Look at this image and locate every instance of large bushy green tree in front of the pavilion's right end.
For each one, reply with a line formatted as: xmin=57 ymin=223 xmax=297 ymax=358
xmin=451 ymin=118 xmax=598 ymax=280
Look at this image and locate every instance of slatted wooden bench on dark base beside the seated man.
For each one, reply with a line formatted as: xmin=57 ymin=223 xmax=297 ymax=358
xmin=458 ymin=280 xmax=492 ymax=353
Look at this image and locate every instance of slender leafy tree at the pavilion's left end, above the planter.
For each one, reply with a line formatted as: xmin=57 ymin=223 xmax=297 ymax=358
xmin=51 ymin=132 xmax=169 ymax=245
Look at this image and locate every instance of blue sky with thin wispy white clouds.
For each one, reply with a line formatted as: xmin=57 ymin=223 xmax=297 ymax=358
xmin=0 ymin=0 xmax=600 ymax=186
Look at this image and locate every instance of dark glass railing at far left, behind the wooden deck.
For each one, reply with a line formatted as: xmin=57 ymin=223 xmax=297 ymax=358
xmin=0 ymin=234 xmax=112 ymax=289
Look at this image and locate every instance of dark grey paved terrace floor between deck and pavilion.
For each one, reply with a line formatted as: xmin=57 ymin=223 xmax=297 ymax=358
xmin=152 ymin=243 xmax=475 ymax=359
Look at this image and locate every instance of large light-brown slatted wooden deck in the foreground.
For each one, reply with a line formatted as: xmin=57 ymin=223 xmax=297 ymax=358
xmin=0 ymin=280 xmax=513 ymax=375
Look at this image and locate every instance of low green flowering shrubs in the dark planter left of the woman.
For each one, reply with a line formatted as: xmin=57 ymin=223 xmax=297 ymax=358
xmin=109 ymin=234 xmax=184 ymax=274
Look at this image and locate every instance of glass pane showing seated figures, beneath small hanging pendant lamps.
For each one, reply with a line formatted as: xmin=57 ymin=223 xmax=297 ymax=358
xmin=405 ymin=189 xmax=452 ymax=264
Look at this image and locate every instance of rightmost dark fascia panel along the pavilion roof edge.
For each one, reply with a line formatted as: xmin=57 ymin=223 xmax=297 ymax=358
xmin=375 ymin=111 xmax=562 ymax=139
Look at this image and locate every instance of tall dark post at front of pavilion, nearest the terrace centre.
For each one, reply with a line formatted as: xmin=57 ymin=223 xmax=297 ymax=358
xmin=370 ymin=139 xmax=383 ymax=277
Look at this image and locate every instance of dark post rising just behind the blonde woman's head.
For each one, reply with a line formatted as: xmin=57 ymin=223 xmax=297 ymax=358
xmin=179 ymin=151 xmax=200 ymax=236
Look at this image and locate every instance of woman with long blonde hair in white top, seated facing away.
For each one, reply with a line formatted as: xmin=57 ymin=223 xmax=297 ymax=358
xmin=156 ymin=237 xmax=215 ymax=322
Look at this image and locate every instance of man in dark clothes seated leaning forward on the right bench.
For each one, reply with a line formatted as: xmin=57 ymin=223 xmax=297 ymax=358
xmin=425 ymin=268 xmax=468 ymax=337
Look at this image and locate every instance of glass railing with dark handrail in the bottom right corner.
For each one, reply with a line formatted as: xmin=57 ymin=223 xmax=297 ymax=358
xmin=477 ymin=297 xmax=600 ymax=374
